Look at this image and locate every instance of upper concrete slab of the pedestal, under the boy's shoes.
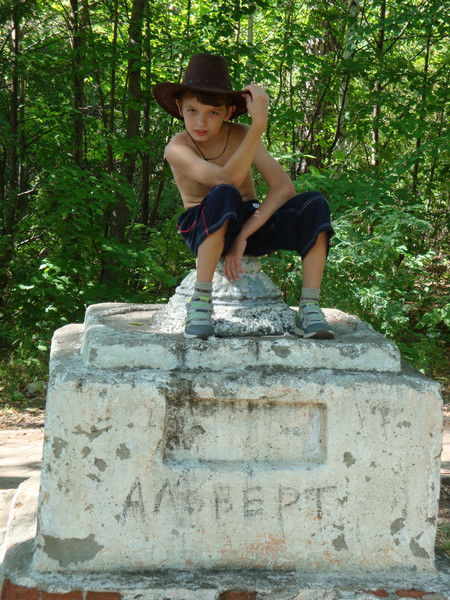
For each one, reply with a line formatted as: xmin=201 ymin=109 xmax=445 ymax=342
xmin=81 ymin=303 xmax=401 ymax=373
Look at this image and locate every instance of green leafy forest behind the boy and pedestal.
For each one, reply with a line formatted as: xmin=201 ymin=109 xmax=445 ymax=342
xmin=0 ymin=0 xmax=450 ymax=411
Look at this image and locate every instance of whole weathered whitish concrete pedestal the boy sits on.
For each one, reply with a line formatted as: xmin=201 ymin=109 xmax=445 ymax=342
xmin=0 ymin=257 xmax=442 ymax=600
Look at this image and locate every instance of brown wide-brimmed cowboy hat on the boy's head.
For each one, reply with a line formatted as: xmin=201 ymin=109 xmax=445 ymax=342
xmin=152 ymin=53 xmax=247 ymax=119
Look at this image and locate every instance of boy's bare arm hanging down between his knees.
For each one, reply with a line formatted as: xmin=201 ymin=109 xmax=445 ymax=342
xmin=224 ymin=142 xmax=296 ymax=281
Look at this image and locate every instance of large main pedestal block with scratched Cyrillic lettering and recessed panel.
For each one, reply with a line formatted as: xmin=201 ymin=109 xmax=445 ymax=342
xmin=21 ymin=314 xmax=442 ymax=575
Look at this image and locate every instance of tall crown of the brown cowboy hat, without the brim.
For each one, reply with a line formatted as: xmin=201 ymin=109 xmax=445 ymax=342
xmin=183 ymin=53 xmax=233 ymax=92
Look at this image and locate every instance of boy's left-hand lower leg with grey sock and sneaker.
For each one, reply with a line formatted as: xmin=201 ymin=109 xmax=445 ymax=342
xmin=184 ymin=220 xmax=229 ymax=339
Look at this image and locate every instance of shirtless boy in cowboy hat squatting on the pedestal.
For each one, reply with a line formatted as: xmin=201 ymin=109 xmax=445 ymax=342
xmin=153 ymin=54 xmax=334 ymax=339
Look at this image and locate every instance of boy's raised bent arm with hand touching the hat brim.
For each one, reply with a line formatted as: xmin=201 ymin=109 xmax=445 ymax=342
xmin=164 ymin=85 xmax=269 ymax=187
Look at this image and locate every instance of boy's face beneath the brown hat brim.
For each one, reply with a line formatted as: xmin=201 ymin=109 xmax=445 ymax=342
xmin=176 ymin=96 xmax=234 ymax=142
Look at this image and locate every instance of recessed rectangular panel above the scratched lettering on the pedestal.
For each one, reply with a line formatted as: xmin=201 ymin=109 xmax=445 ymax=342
xmin=164 ymin=398 xmax=326 ymax=468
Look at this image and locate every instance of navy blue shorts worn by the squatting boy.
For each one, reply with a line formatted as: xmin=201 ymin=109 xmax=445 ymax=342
xmin=177 ymin=184 xmax=334 ymax=258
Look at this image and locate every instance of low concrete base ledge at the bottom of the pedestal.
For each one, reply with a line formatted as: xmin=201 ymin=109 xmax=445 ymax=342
xmin=0 ymin=478 xmax=450 ymax=600
